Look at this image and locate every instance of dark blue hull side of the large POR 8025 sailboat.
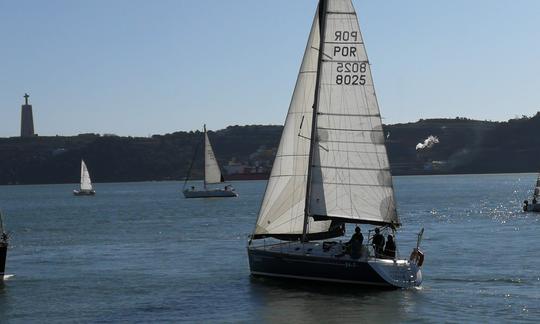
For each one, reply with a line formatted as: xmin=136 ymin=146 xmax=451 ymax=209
xmin=248 ymin=248 xmax=393 ymax=287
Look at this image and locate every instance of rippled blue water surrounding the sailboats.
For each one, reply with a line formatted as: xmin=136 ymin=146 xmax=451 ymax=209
xmin=0 ymin=174 xmax=540 ymax=323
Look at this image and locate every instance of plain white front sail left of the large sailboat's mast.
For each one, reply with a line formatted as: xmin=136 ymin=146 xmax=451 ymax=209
xmin=254 ymin=6 xmax=330 ymax=235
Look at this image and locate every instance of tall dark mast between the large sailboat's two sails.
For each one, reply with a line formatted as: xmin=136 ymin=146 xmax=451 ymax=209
xmin=302 ymin=0 xmax=327 ymax=242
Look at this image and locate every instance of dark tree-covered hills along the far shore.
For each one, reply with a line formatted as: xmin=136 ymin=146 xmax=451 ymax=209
xmin=0 ymin=113 xmax=540 ymax=184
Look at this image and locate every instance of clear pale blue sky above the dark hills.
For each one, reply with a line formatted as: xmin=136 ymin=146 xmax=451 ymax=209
xmin=0 ymin=0 xmax=540 ymax=137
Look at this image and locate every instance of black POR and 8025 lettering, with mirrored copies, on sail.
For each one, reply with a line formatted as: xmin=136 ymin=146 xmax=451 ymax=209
xmin=334 ymin=30 xmax=367 ymax=85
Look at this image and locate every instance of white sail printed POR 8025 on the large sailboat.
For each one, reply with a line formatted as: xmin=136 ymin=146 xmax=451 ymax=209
xmin=309 ymin=0 xmax=399 ymax=223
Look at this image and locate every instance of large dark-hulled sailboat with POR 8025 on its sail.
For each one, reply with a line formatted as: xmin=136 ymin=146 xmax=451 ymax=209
xmin=247 ymin=0 xmax=424 ymax=288
